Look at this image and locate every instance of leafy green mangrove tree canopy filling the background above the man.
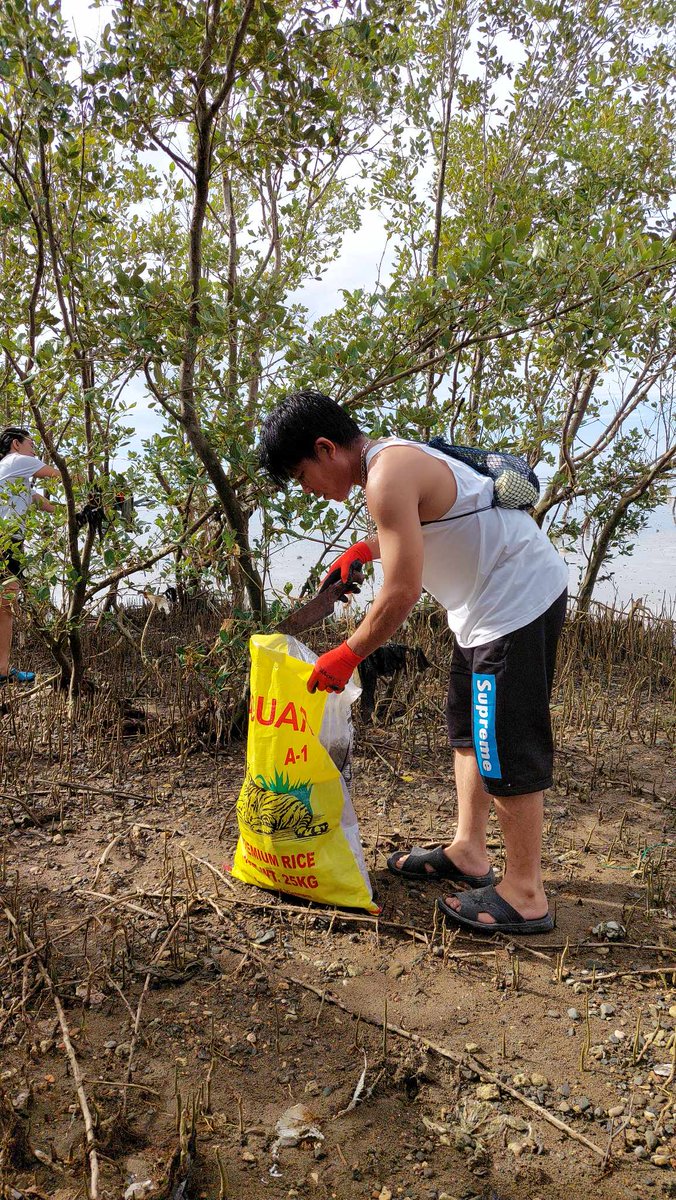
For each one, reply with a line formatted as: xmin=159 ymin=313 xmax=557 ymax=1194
xmin=0 ymin=0 xmax=676 ymax=686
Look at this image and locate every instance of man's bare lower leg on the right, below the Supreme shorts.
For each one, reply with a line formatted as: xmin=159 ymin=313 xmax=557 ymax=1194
xmin=444 ymin=770 xmax=549 ymax=924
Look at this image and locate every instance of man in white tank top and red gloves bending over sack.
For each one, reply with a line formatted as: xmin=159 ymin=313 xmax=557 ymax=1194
xmin=259 ymin=390 xmax=568 ymax=934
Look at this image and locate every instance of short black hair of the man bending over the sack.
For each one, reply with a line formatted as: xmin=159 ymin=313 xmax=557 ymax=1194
xmin=258 ymin=390 xmax=361 ymax=487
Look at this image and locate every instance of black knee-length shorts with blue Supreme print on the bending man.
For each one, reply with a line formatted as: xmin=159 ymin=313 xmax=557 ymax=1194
xmin=447 ymin=592 xmax=568 ymax=796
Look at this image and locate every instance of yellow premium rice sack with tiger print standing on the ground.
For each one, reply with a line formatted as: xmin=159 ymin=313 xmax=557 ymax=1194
xmin=232 ymin=634 xmax=378 ymax=912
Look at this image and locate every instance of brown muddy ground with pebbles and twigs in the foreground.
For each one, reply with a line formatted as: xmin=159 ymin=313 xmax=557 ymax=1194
xmin=0 ymin=691 xmax=676 ymax=1200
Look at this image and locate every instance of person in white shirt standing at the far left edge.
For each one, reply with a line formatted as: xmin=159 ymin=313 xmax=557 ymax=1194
xmin=0 ymin=425 xmax=60 ymax=685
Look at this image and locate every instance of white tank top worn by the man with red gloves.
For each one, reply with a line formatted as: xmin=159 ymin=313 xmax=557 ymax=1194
xmin=366 ymin=438 xmax=568 ymax=648
